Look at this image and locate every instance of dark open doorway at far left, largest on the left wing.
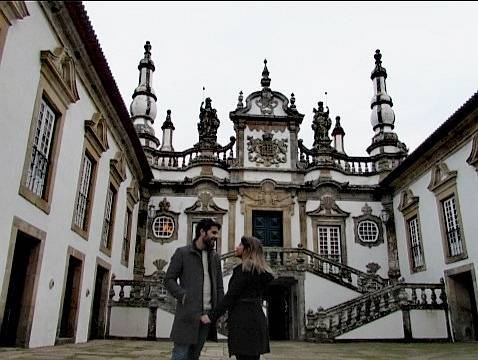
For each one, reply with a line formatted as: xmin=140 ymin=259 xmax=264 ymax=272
xmin=0 ymin=231 xmax=41 ymax=347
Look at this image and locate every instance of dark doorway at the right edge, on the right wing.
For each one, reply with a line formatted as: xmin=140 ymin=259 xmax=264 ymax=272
xmin=447 ymin=271 xmax=478 ymax=341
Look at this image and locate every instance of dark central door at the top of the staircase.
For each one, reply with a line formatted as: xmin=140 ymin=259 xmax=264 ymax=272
xmin=252 ymin=210 xmax=284 ymax=247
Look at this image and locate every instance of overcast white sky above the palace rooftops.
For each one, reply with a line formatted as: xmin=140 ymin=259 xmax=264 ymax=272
xmin=85 ymin=1 xmax=478 ymax=156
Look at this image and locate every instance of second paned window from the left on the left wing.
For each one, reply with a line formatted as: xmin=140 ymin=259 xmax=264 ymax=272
xmin=74 ymin=153 xmax=95 ymax=230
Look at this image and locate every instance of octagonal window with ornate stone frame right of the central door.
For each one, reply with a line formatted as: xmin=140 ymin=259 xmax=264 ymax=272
xmin=353 ymin=203 xmax=383 ymax=248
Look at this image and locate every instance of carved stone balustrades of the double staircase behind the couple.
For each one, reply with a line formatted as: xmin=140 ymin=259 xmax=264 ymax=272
xmin=108 ymin=246 xmax=447 ymax=342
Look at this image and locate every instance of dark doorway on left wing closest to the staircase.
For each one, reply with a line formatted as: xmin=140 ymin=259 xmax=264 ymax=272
xmin=89 ymin=265 xmax=109 ymax=339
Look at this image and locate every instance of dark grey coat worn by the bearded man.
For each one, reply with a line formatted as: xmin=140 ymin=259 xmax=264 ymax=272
xmin=164 ymin=244 xmax=224 ymax=344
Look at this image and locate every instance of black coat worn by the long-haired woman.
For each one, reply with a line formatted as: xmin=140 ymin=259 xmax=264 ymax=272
xmin=209 ymin=265 xmax=274 ymax=356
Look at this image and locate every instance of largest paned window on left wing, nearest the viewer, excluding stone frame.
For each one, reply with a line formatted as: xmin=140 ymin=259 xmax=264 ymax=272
xmin=25 ymin=99 xmax=56 ymax=198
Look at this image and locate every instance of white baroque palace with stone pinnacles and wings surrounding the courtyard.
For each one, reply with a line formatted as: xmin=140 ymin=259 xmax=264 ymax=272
xmin=0 ymin=1 xmax=478 ymax=347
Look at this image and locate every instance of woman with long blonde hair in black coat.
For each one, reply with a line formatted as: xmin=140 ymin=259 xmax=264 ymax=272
xmin=201 ymin=236 xmax=274 ymax=360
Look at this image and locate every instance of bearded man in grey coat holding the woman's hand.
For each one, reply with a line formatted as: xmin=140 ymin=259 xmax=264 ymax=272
xmin=165 ymin=219 xmax=224 ymax=360
